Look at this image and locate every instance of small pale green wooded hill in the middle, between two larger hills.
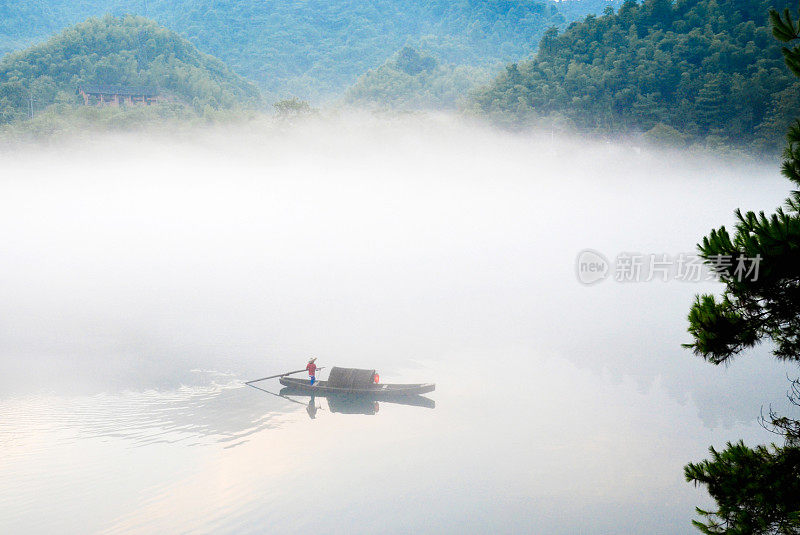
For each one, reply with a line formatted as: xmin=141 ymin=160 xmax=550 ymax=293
xmin=344 ymin=46 xmax=489 ymax=110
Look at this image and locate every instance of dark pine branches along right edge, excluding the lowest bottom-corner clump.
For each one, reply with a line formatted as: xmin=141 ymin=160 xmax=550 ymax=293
xmin=688 ymin=6 xmax=800 ymax=364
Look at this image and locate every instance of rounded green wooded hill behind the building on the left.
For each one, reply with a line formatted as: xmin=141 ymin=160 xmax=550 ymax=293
xmin=0 ymin=15 xmax=260 ymax=123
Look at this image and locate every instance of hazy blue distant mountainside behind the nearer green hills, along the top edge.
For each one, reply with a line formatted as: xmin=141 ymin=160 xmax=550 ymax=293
xmin=0 ymin=0 xmax=619 ymax=98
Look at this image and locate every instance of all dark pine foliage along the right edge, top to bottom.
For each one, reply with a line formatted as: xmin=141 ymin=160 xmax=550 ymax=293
xmin=685 ymin=6 xmax=800 ymax=535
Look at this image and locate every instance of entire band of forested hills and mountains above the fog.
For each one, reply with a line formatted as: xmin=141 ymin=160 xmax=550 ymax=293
xmin=0 ymin=0 xmax=800 ymax=150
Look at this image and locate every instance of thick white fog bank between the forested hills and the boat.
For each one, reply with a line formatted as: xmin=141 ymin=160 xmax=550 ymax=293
xmin=0 ymin=116 xmax=793 ymax=424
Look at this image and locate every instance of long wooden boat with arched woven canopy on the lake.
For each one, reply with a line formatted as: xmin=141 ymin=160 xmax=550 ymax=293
xmin=280 ymin=367 xmax=436 ymax=399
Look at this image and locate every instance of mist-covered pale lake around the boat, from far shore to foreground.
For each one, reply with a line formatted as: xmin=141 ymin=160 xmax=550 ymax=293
xmin=0 ymin=116 xmax=792 ymax=534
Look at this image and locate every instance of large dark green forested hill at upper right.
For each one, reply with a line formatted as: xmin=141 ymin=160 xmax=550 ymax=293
xmin=474 ymin=0 xmax=800 ymax=148
